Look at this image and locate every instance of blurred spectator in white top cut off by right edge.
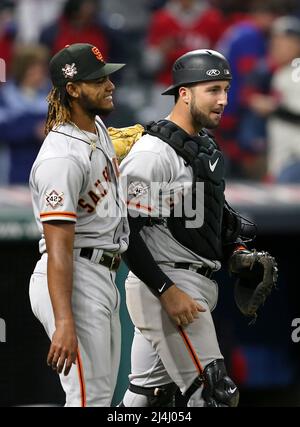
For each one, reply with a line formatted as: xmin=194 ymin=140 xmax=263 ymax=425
xmin=266 ymin=17 xmax=300 ymax=183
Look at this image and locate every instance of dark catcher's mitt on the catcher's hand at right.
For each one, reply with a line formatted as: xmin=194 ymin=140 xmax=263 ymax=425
xmin=229 ymin=249 xmax=278 ymax=321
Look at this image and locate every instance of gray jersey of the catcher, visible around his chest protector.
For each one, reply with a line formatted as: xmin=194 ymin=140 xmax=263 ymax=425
xmin=120 ymin=134 xmax=220 ymax=270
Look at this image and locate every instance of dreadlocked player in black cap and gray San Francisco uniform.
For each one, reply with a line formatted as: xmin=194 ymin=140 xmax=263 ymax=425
xmin=30 ymin=44 xmax=128 ymax=406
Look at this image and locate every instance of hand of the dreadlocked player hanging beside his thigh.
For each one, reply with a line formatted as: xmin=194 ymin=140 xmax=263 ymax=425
xmin=47 ymin=321 xmax=78 ymax=375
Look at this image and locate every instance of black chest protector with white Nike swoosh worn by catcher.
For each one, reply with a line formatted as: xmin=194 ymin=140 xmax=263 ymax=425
xmin=146 ymin=120 xmax=225 ymax=259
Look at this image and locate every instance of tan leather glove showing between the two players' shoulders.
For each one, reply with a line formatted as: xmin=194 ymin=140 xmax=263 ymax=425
xmin=107 ymin=124 xmax=144 ymax=161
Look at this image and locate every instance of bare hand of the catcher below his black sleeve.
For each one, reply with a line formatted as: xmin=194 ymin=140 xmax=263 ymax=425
xmin=160 ymin=285 xmax=206 ymax=326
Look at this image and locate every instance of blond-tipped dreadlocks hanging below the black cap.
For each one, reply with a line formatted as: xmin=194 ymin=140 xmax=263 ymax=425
xmin=45 ymin=87 xmax=71 ymax=135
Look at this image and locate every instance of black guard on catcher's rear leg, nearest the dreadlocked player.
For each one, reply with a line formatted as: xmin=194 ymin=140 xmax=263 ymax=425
xmin=128 ymin=383 xmax=178 ymax=408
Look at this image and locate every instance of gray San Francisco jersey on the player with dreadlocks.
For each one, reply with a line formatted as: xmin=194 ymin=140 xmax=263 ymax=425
xmin=30 ymin=118 xmax=128 ymax=253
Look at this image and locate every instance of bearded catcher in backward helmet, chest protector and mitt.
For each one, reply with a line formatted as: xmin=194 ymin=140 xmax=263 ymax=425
xmin=116 ymin=50 xmax=276 ymax=407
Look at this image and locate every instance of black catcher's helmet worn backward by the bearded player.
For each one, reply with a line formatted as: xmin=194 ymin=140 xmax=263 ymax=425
xmin=162 ymin=49 xmax=232 ymax=95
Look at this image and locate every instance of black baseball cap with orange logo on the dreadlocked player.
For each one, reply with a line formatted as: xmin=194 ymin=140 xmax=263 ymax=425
xmin=49 ymin=43 xmax=125 ymax=87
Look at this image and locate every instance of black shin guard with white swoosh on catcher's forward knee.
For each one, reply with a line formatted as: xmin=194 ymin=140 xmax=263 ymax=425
xmin=185 ymin=359 xmax=239 ymax=407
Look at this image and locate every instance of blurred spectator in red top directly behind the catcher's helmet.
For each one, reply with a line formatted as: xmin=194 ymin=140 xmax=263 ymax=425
xmin=145 ymin=0 xmax=223 ymax=87
